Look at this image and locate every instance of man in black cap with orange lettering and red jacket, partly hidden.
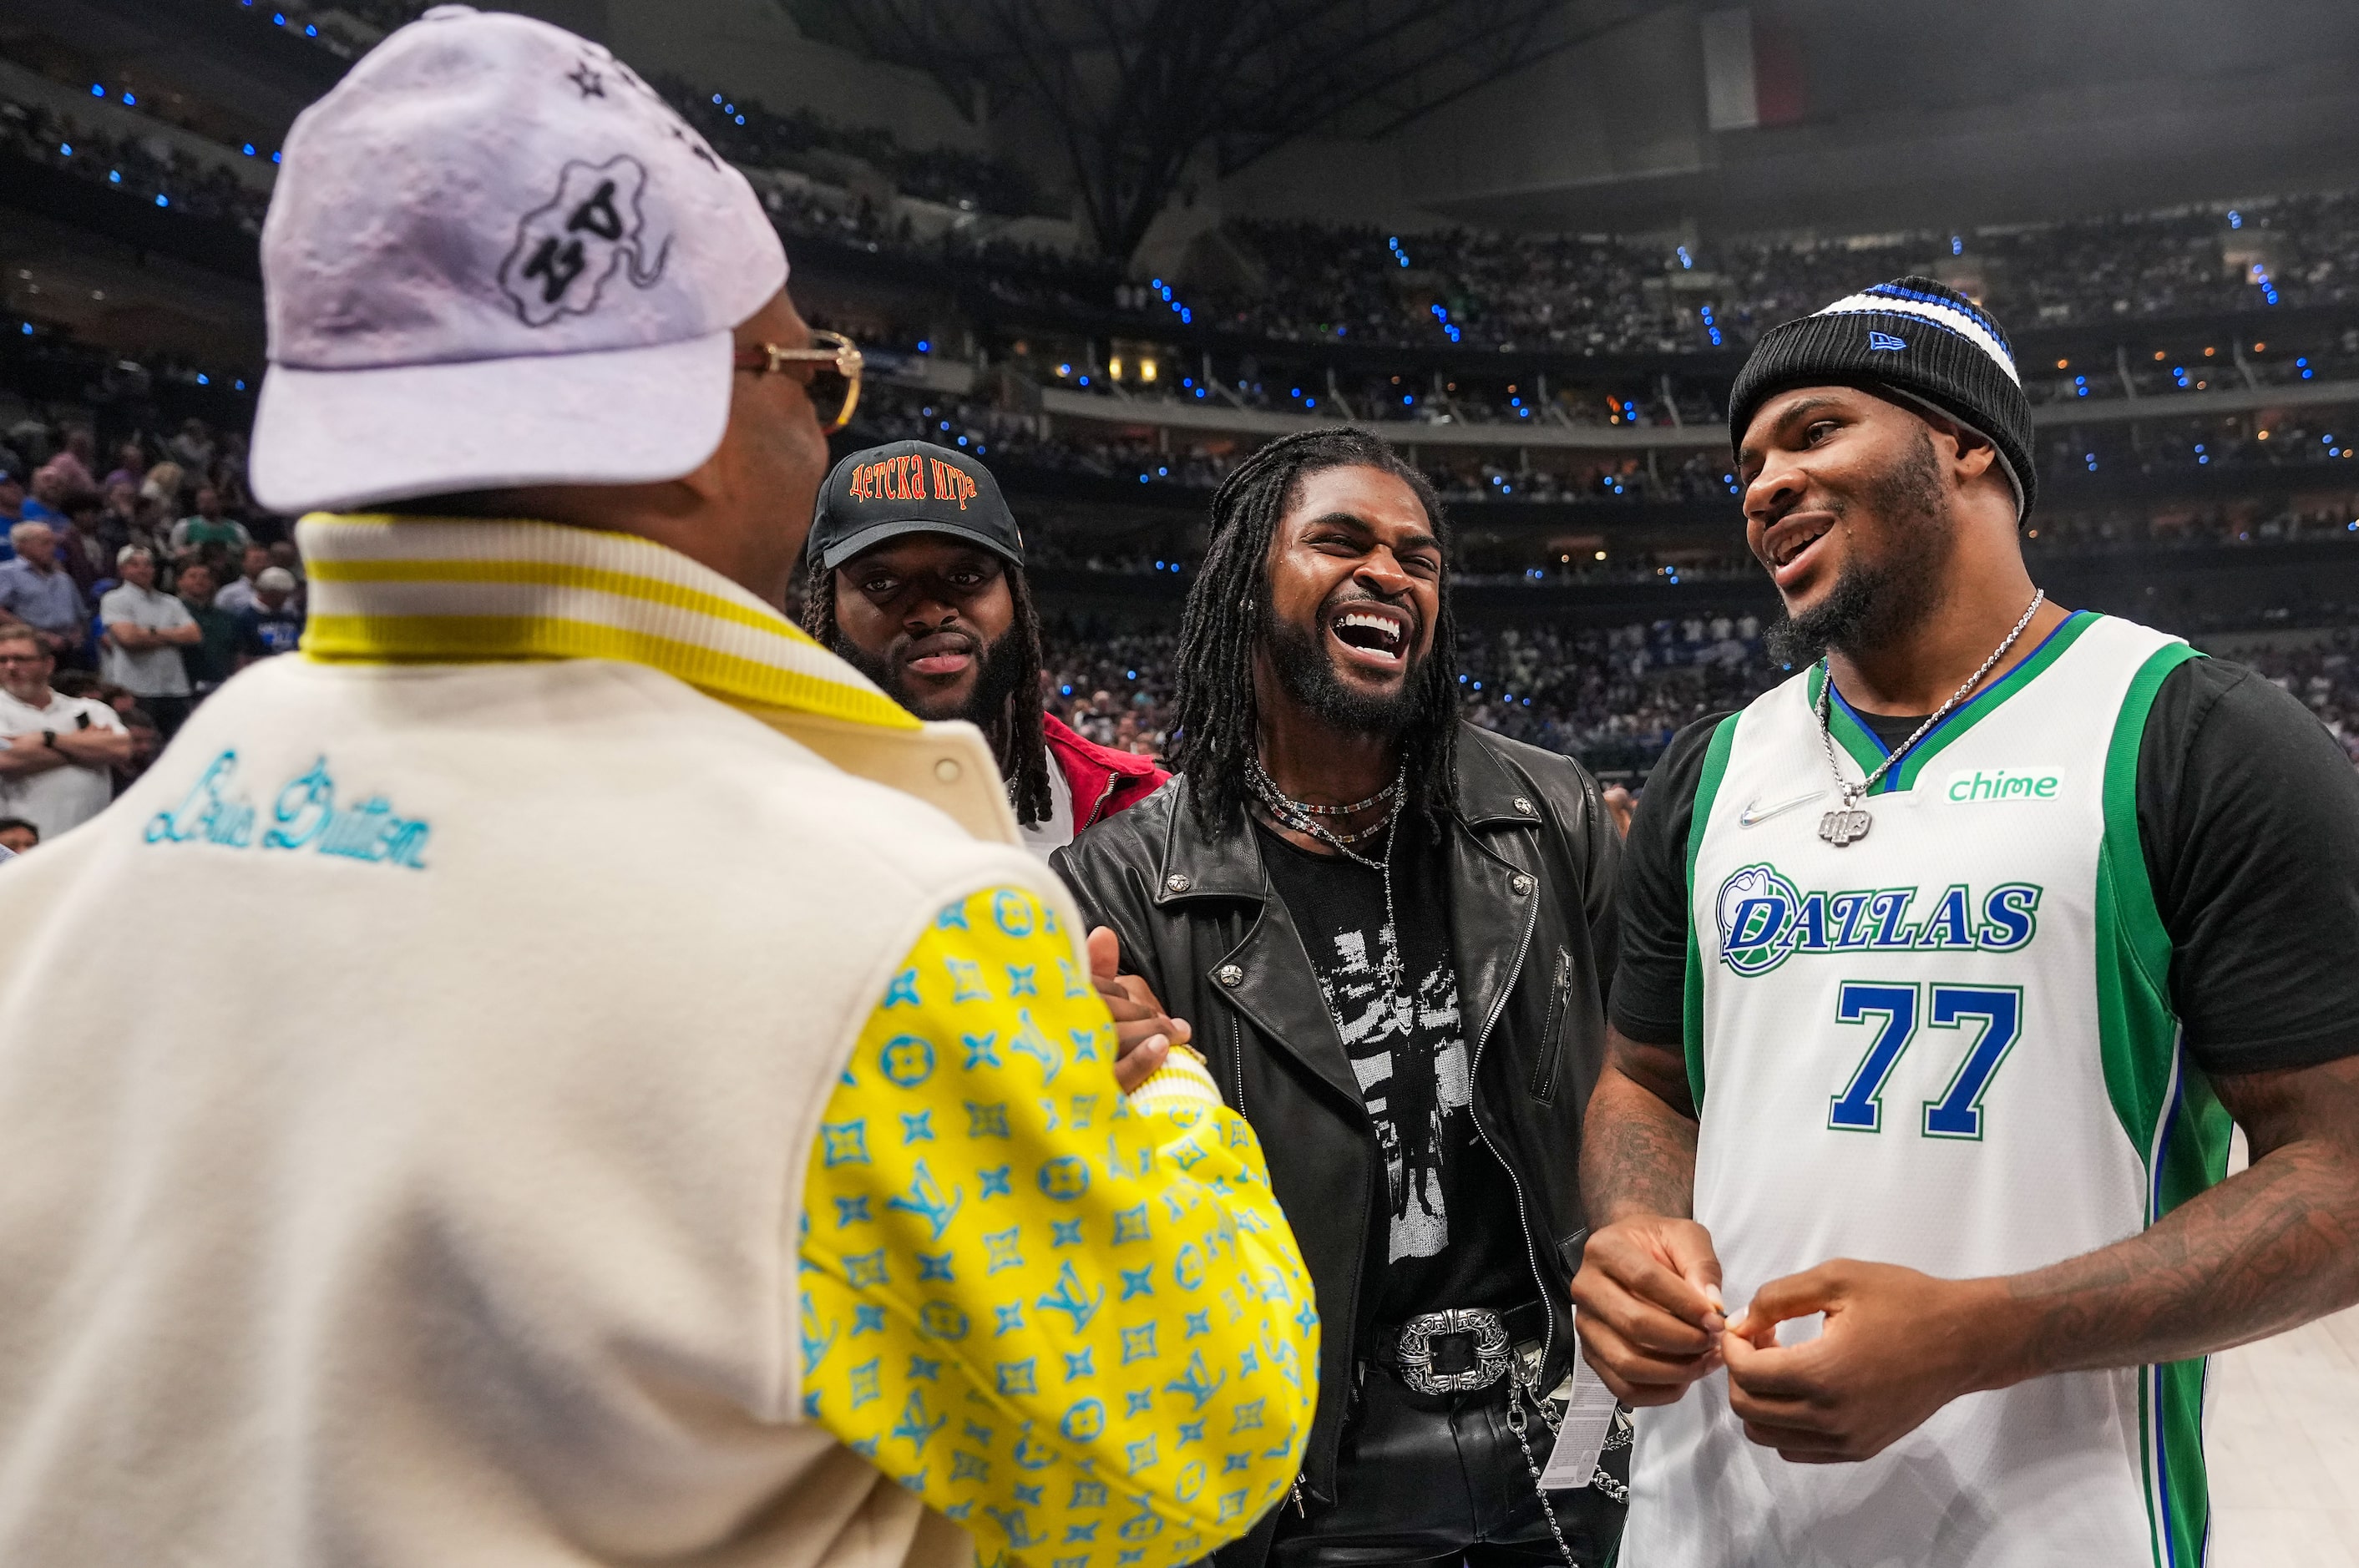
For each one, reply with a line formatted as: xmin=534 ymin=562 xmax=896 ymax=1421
xmin=802 ymin=441 xmax=1167 ymax=856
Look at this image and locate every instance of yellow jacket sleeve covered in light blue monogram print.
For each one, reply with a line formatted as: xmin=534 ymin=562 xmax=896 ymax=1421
xmin=802 ymin=889 xmax=1319 ymax=1568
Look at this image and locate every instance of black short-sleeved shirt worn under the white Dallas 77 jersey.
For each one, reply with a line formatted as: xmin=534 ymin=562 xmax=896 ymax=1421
xmin=1611 ymin=658 xmax=2359 ymax=1073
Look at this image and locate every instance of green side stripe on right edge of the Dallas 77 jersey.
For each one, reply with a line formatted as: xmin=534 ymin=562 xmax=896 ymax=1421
xmin=2103 ymin=644 xmax=2230 ymax=1568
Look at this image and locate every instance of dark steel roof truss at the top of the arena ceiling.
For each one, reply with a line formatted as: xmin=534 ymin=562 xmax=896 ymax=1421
xmin=783 ymin=0 xmax=1668 ymax=260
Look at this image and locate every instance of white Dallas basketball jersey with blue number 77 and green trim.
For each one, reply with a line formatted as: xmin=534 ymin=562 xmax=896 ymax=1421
xmin=1621 ymin=613 xmax=2227 ymax=1568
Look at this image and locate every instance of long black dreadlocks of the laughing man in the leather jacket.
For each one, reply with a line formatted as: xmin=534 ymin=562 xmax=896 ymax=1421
xmin=1170 ymin=424 xmax=1458 ymax=835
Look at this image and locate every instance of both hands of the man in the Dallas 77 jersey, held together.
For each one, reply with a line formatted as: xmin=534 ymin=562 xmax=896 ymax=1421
xmin=1573 ymin=1214 xmax=2015 ymax=1464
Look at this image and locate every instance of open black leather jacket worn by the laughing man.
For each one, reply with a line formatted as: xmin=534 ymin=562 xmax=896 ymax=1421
xmin=1052 ymin=724 xmax=1621 ymax=1561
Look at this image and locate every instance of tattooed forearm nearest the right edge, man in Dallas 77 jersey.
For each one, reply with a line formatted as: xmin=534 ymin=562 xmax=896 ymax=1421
xmin=2005 ymin=1064 xmax=2359 ymax=1377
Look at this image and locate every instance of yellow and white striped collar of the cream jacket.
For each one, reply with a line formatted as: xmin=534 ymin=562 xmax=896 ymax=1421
xmin=295 ymin=512 xmax=918 ymax=729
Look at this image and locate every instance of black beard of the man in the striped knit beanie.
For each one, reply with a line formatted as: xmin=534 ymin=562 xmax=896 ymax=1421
xmin=1764 ymin=429 xmax=1958 ymax=667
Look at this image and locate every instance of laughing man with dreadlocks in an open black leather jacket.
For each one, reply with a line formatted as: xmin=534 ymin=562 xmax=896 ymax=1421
xmin=1052 ymin=429 xmax=1621 ymax=1568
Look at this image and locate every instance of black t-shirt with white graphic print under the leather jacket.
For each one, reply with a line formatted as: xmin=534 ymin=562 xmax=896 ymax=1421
xmin=1258 ymin=825 xmax=1533 ymax=1325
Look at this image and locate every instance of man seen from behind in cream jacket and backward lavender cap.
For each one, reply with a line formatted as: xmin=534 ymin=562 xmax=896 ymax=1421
xmin=0 ymin=7 xmax=1319 ymax=1568
